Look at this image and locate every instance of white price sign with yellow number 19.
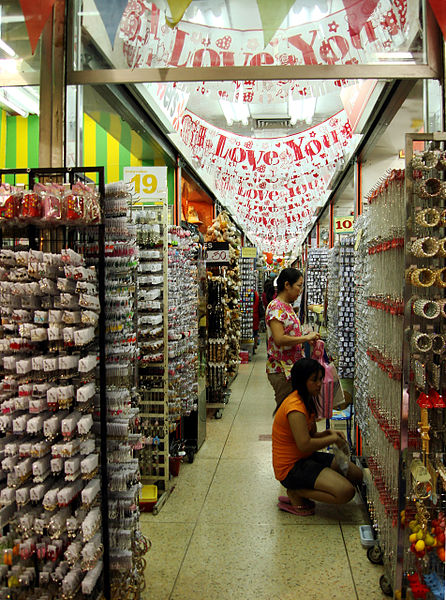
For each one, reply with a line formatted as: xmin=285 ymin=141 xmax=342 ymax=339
xmin=124 ymin=167 xmax=167 ymax=205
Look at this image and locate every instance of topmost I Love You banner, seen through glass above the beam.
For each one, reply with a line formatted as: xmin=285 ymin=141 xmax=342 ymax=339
xmin=119 ymin=0 xmax=407 ymax=82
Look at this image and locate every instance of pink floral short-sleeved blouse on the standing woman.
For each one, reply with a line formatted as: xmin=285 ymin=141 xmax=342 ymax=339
xmin=265 ymin=298 xmax=304 ymax=379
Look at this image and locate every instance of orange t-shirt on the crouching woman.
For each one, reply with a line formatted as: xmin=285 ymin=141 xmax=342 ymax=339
xmin=272 ymin=391 xmax=315 ymax=481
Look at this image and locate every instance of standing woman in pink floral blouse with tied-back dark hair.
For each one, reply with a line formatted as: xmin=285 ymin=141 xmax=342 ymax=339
xmin=265 ymin=268 xmax=320 ymax=404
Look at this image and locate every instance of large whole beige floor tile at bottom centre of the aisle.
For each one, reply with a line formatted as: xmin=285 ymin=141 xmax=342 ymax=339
xmin=171 ymin=523 xmax=356 ymax=600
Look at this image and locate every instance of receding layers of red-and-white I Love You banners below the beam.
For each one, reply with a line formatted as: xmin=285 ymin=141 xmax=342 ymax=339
xmin=175 ymin=111 xmax=352 ymax=252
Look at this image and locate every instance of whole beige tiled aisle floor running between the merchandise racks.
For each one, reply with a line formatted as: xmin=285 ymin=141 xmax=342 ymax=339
xmin=142 ymin=343 xmax=383 ymax=600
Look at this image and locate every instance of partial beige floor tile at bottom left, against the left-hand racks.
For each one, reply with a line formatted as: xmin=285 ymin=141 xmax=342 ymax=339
xmin=140 ymin=521 xmax=194 ymax=600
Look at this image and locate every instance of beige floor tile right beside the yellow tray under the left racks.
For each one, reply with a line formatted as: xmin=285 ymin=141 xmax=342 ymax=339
xmin=141 ymin=460 xmax=217 ymax=523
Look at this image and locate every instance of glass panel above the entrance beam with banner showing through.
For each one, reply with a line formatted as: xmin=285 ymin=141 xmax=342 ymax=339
xmin=76 ymin=0 xmax=425 ymax=69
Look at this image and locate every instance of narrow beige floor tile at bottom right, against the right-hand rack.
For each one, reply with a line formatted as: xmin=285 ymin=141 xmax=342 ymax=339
xmin=341 ymin=522 xmax=388 ymax=600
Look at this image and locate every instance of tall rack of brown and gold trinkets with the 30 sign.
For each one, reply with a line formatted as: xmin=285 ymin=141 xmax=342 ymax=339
xmin=205 ymin=213 xmax=240 ymax=409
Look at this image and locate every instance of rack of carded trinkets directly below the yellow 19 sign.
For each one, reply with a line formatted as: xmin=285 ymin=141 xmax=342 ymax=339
xmin=132 ymin=199 xmax=170 ymax=492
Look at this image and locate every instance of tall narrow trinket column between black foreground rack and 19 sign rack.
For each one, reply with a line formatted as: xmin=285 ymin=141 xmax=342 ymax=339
xmin=104 ymin=182 xmax=147 ymax=600
